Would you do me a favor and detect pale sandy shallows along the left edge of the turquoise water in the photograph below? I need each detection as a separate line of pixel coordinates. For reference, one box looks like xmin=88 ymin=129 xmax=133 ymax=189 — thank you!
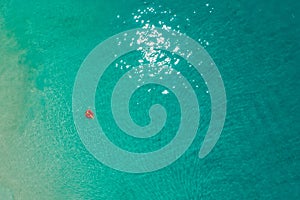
xmin=0 ymin=16 xmax=59 ymax=199
